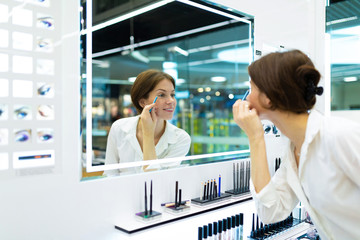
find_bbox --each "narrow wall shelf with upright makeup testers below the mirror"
[115,159,251,233]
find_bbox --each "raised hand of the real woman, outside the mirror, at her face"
[233,100,264,140]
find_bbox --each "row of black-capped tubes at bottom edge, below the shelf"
[198,213,244,240]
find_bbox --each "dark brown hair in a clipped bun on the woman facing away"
[248,50,323,113]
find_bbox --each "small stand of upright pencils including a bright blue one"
[191,175,231,205]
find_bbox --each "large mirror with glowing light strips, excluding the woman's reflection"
[81,0,253,177]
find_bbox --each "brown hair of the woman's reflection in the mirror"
[130,69,175,113]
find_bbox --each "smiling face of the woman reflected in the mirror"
[146,79,176,120]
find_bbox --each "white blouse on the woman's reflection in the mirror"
[104,116,191,176]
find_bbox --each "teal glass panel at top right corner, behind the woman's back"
[326,0,360,110]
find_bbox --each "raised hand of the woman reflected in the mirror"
[140,103,158,138]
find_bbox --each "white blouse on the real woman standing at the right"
[251,110,360,240]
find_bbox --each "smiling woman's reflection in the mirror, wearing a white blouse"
[104,69,191,175]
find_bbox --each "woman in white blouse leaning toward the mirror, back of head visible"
[233,50,360,239]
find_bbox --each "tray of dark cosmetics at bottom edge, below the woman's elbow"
[249,214,300,239]
